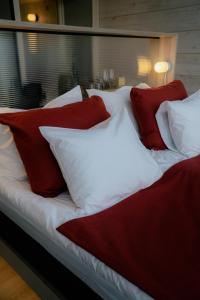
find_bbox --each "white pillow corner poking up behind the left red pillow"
[44,85,83,108]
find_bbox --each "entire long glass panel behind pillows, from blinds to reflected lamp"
[0,31,156,108]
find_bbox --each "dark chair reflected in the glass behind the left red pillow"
[21,82,45,109]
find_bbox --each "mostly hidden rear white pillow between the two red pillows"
[87,83,149,134]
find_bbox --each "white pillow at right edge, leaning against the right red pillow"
[156,90,200,157]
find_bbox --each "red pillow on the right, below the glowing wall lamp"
[131,80,187,150]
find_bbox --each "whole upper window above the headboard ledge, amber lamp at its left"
[20,0,92,27]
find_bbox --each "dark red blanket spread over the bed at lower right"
[58,156,200,300]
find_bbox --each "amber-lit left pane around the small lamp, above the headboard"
[20,0,59,24]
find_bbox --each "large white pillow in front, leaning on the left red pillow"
[40,109,162,209]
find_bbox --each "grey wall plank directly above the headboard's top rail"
[100,2,200,32]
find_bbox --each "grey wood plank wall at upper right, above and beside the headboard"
[99,0,200,93]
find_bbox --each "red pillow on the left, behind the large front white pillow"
[0,96,110,197]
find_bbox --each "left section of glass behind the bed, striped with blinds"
[0,31,92,108]
